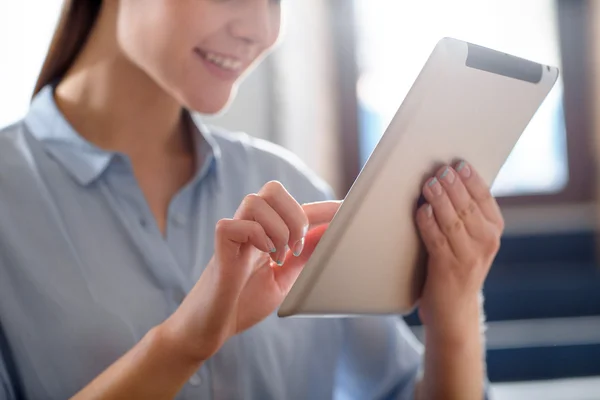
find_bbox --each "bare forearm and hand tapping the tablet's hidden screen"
[68,188,339,400]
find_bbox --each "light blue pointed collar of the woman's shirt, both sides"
[24,85,221,185]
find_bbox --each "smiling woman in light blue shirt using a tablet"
[0,0,502,399]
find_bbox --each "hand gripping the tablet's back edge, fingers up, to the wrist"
[417,161,504,339]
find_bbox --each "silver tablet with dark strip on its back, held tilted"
[278,38,558,317]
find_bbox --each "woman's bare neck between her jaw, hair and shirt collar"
[55,1,191,159]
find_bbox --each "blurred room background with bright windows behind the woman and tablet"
[0,0,600,400]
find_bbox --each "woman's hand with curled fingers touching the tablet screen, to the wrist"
[161,181,341,361]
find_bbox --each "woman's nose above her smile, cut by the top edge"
[231,0,280,47]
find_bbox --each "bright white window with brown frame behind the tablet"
[354,0,569,196]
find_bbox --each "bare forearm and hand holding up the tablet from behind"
[417,162,504,400]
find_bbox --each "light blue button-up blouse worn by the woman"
[0,86,421,400]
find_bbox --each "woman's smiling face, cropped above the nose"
[117,0,281,114]
